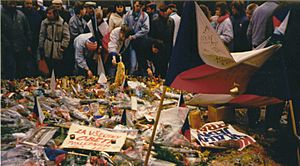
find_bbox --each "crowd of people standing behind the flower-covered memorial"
[1,0,296,79]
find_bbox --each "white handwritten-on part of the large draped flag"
[196,5,281,69]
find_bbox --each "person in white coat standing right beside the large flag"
[167,3,181,46]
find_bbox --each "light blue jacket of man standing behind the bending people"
[123,11,150,38]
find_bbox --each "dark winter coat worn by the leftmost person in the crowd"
[1,7,32,53]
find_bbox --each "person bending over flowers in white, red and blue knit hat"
[74,33,102,78]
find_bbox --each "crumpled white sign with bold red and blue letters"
[192,121,255,150]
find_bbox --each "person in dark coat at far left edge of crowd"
[1,1,32,79]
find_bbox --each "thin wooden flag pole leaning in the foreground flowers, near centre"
[144,86,167,166]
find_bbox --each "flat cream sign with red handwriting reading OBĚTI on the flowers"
[61,124,127,152]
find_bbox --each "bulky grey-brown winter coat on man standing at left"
[39,17,70,59]
